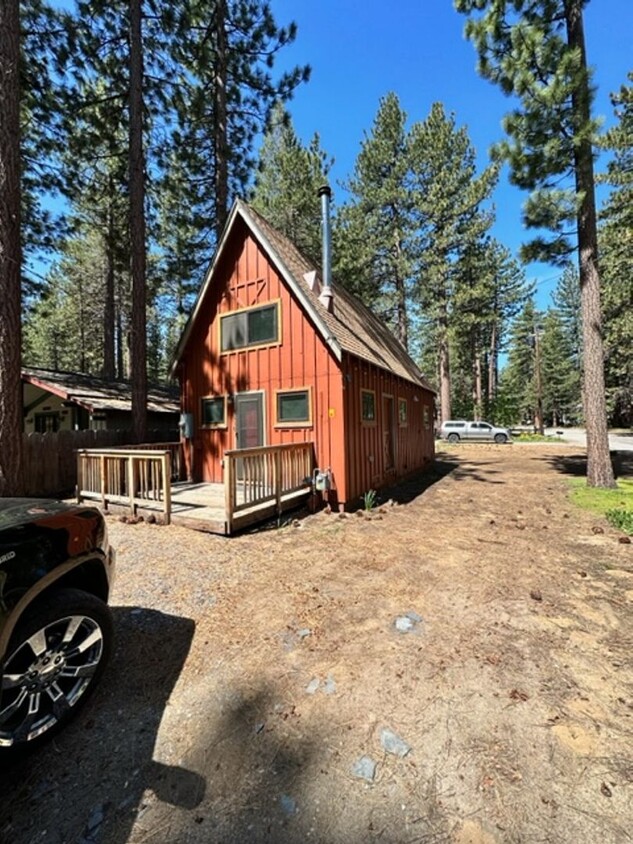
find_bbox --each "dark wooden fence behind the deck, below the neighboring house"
[22,430,181,497]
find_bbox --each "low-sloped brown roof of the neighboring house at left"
[22,367,179,413]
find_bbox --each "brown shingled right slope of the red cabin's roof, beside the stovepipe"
[240,202,433,391]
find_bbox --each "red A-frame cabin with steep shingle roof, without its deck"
[173,195,434,508]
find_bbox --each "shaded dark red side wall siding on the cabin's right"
[343,355,435,508]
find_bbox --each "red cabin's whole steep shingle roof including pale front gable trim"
[174,199,433,391]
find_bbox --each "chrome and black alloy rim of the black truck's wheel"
[0,615,103,747]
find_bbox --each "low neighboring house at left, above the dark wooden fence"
[22,368,179,435]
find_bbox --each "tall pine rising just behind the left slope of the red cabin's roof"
[164,0,310,258]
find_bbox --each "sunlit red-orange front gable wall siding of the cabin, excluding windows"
[181,222,347,501]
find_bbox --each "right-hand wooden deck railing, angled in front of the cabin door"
[224,442,314,533]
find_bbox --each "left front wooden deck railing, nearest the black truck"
[77,445,172,524]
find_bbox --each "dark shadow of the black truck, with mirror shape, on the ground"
[0,607,205,844]
